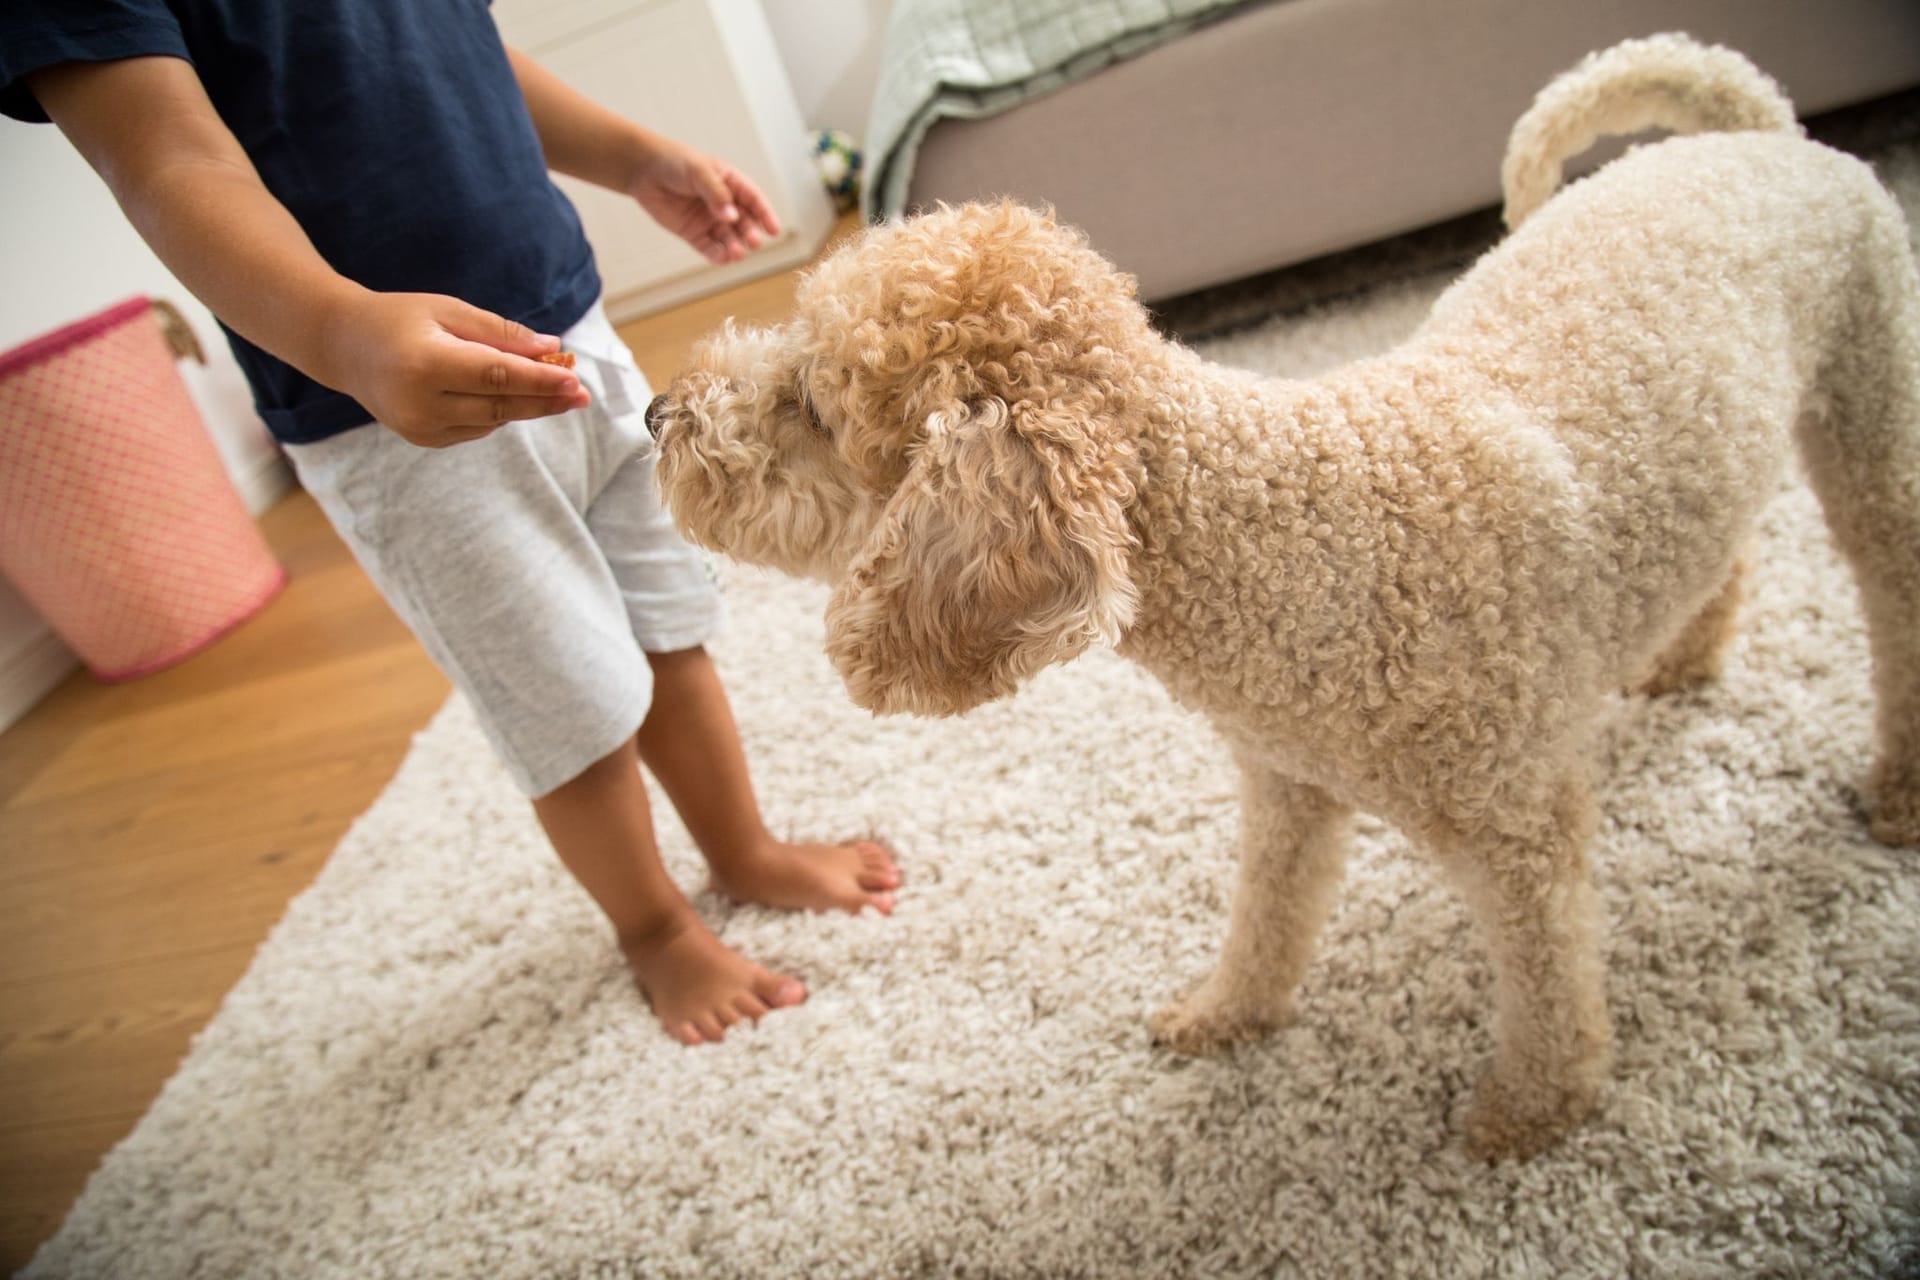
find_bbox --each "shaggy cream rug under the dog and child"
[31,160,1920,1278]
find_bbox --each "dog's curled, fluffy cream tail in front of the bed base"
[1500,35,1801,230]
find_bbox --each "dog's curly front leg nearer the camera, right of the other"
[1423,766,1613,1159]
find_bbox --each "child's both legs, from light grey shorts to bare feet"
[288,313,899,1042]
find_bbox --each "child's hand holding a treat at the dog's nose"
[317,290,589,449]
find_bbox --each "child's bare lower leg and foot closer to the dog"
[639,649,900,912]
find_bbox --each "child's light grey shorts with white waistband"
[286,307,724,796]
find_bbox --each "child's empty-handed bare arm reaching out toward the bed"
[507,48,780,263]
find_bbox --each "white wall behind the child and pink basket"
[0,0,891,729]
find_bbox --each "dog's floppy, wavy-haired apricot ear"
[828,395,1135,716]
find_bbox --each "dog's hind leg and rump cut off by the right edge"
[1799,211,1920,844]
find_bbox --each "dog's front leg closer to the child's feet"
[1152,758,1352,1054]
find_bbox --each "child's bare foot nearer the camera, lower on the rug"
[620,912,806,1044]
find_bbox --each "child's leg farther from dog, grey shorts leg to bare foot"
[288,378,871,1042]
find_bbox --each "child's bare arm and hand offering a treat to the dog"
[29,58,586,447]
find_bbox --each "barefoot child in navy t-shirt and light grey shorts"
[0,0,900,1044]
